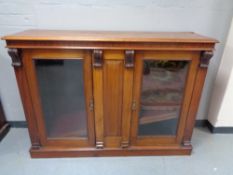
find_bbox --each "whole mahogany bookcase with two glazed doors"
[3,30,217,158]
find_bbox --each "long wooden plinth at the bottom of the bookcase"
[30,146,191,158]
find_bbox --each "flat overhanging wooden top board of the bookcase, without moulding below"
[2,30,218,43]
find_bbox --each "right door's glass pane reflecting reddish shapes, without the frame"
[138,60,188,136]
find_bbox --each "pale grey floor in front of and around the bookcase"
[0,128,233,175]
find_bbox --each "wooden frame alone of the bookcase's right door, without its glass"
[131,51,200,147]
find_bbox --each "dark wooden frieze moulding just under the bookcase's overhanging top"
[7,40,214,51]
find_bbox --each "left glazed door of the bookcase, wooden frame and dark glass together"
[23,49,95,147]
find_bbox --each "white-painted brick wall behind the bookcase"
[0,0,233,121]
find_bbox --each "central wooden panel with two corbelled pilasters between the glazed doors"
[93,50,134,148]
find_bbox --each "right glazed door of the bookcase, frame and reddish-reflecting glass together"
[131,51,199,146]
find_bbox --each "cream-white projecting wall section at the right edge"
[208,19,233,127]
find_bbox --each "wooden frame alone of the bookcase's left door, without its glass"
[22,49,95,147]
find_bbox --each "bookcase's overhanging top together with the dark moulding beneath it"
[2,30,218,51]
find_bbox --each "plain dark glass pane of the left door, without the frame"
[35,60,87,138]
